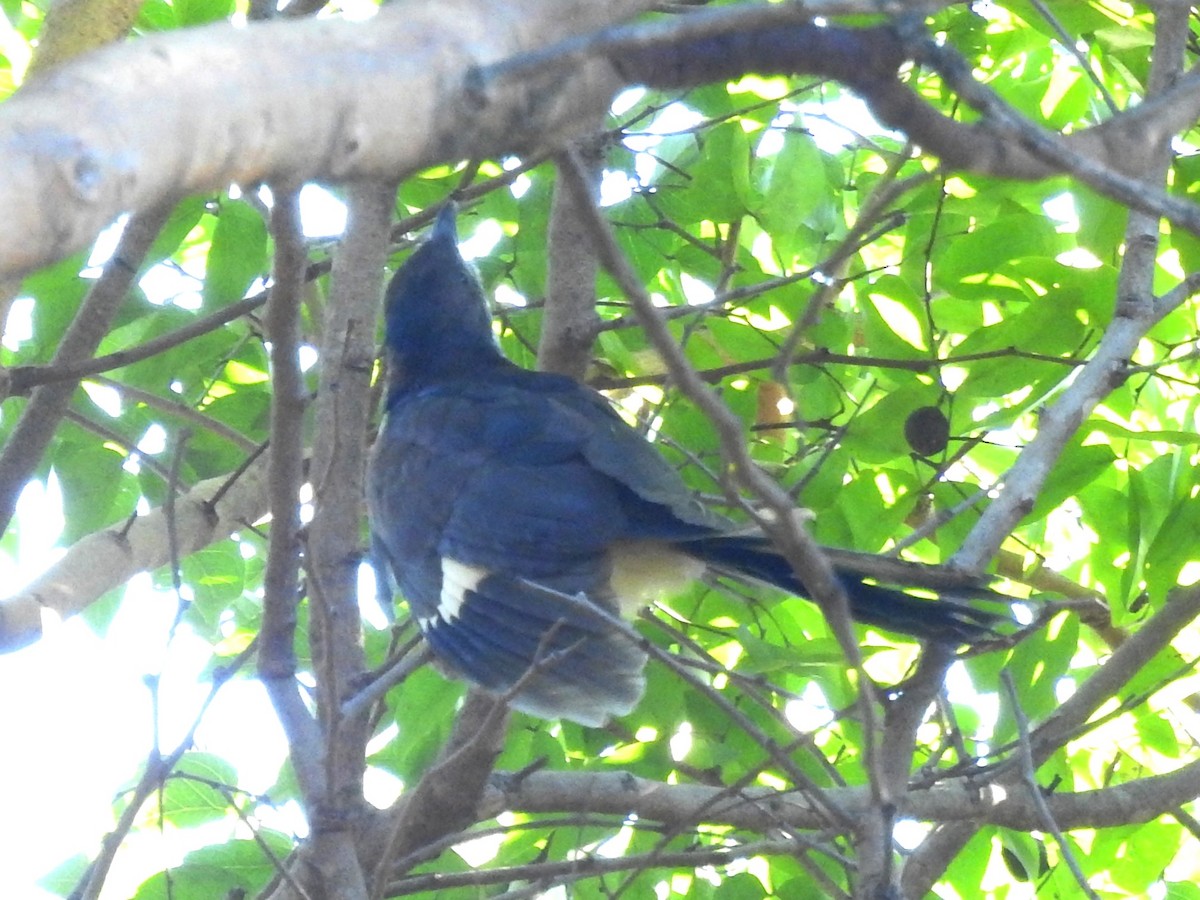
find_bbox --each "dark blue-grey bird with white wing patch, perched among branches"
[367,203,1000,727]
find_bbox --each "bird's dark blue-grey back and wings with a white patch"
[370,372,706,724]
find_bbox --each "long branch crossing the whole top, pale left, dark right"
[7,0,1200,275]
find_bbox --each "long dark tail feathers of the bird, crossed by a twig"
[679,535,1013,644]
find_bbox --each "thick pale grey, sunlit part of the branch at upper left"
[0,0,653,274]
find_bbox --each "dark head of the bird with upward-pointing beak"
[385,203,504,394]
